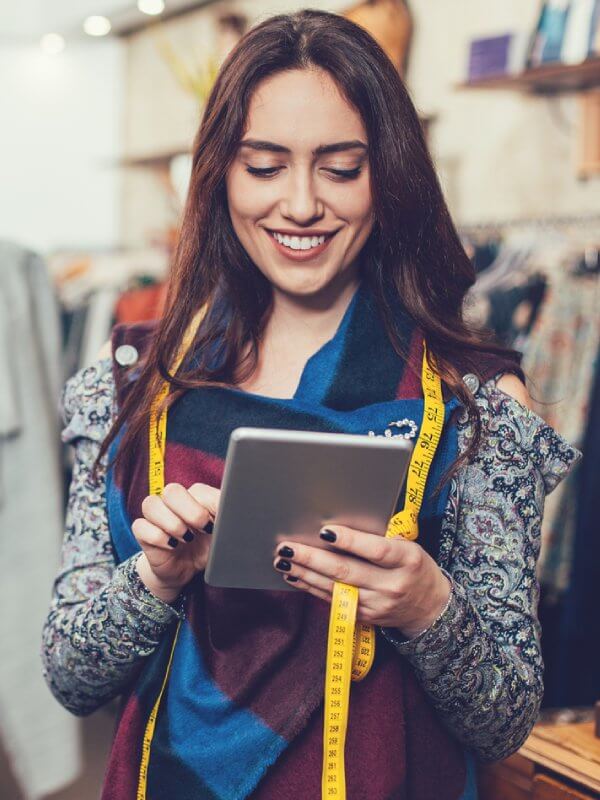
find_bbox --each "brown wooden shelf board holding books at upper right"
[457,56,600,94]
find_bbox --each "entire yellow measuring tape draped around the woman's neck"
[136,306,444,800]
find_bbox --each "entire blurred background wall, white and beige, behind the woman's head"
[0,0,600,251]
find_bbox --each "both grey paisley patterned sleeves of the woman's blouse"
[38,359,579,760]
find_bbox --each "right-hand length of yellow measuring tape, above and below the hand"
[321,347,444,800]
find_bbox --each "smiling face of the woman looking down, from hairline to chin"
[226,69,374,296]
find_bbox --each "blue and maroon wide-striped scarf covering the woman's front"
[103,281,488,800]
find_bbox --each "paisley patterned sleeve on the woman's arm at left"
[42,358,182,715]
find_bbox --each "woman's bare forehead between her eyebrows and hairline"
[245,69,367,150]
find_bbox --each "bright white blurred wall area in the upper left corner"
[0,5,126,252]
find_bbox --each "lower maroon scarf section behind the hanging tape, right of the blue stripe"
[252,638,466,800]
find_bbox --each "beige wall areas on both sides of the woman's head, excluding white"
[123,0,600,244]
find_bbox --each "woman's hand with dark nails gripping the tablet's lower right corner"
[273,525,451,638]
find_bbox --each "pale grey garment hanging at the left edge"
[0,241,80,798]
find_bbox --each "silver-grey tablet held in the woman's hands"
[204,427,413,591]
